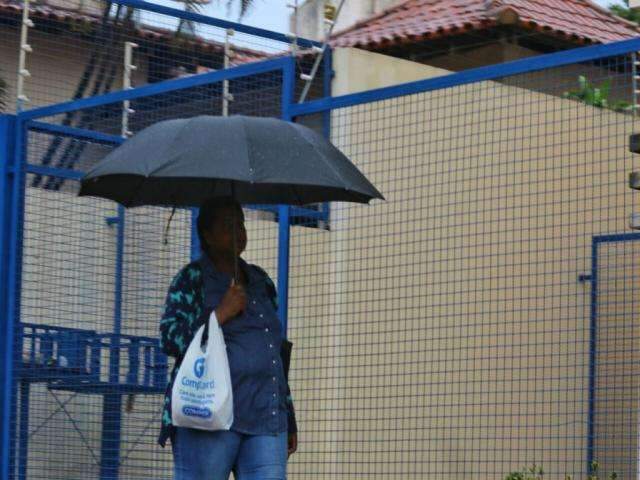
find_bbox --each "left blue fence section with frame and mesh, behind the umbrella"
[0,53,319,479]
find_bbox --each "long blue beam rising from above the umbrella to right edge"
[289,38,640,116]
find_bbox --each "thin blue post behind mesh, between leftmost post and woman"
[100,205,125,480]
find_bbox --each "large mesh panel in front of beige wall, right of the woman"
[289,54,639,479]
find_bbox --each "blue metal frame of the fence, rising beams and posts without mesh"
[0,27,640,480]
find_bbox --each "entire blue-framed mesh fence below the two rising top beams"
[0,5,640,480]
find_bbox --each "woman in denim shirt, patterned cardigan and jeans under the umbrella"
[159,199,297,480]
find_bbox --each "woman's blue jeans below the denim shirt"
[172,427,287,480]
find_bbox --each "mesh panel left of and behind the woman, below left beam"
[9,55,282,479]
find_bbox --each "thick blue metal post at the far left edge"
[0,115,16,480]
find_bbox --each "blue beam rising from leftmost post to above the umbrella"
[18,57,289,121]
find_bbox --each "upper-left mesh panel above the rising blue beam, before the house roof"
[0,0,324,111]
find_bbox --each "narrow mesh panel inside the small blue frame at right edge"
[591,235,640,478]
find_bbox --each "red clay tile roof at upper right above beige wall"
[332,0,640,48]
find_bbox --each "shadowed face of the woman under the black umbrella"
[204,205,247,256]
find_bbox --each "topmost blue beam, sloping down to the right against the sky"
[114,0,322,47]
